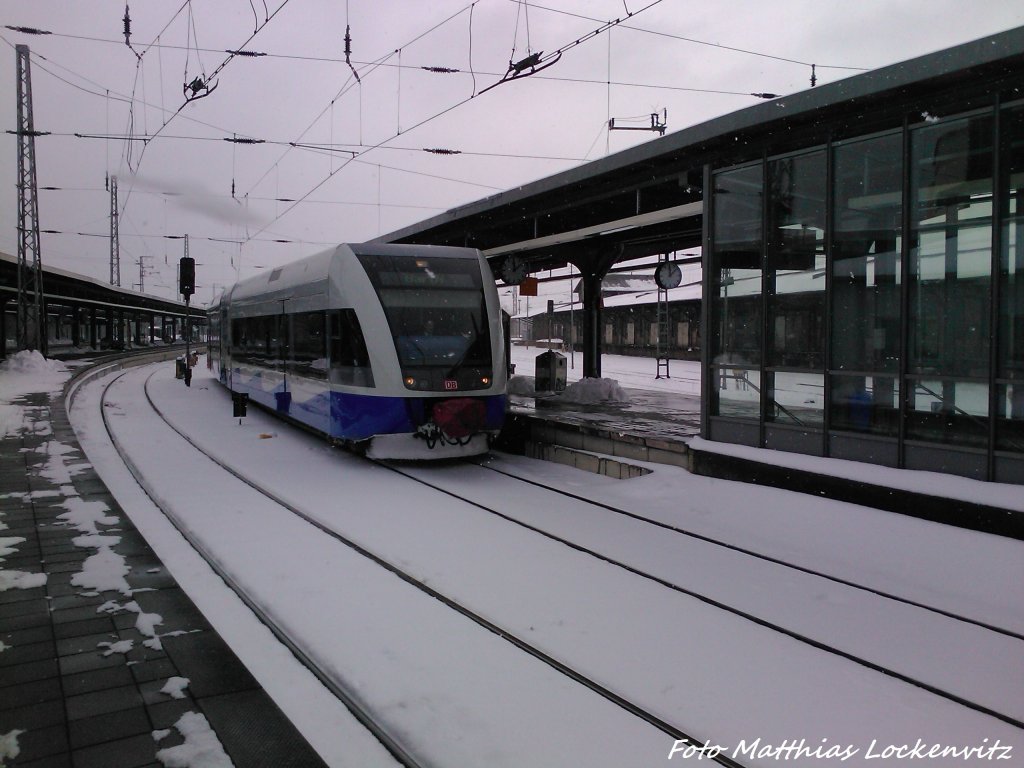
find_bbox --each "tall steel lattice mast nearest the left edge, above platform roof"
[14,45,46,354]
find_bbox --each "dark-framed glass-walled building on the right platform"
[703,99,1024,483]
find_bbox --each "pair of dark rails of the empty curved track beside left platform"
[94,364,743,768]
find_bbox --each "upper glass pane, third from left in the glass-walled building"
[831,133,903,374]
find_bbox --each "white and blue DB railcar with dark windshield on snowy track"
[208,243,508,459]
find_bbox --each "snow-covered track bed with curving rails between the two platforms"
[74,367,1024,768]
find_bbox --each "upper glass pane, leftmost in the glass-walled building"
[711,165,764,366]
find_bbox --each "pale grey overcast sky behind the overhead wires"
[0,0,1024,303]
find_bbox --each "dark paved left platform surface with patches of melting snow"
[0,368,324,768]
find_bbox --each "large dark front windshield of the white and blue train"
[358,255,490,388]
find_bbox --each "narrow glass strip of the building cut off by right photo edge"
[995,106,1024,452]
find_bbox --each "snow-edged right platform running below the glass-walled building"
[502,376,1024,539]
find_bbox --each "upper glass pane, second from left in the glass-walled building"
[767,152,825,369]
